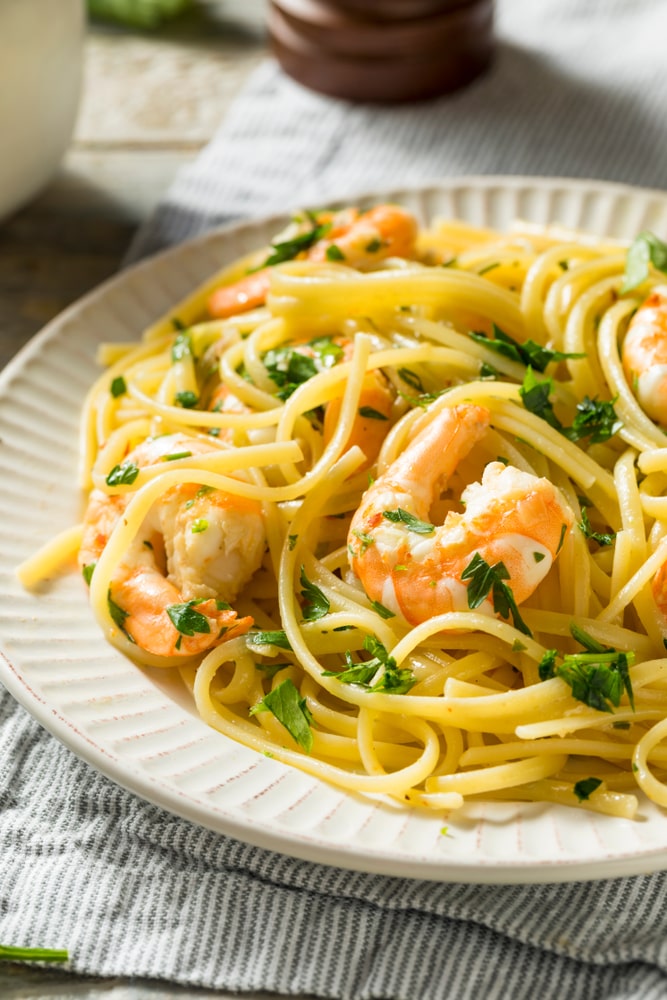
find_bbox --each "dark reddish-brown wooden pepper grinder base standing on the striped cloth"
[268,0,493,103]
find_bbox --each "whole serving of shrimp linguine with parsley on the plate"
[19,206,667,817]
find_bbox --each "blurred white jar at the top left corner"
[0,0,85,219]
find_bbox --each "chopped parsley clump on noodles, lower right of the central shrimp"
[539,623,635,712]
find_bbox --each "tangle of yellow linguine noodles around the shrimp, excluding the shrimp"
[22,211,667,817]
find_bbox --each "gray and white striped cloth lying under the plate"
[0,0,667,1000]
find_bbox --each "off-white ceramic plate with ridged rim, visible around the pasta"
[0,177,667,882]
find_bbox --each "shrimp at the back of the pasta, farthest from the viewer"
[208,205,417,318]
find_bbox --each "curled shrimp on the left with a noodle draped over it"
[79,434,265,656]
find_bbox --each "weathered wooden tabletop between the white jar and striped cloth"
[0,0,267,367]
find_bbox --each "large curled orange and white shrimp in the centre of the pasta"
[348,404,574,625]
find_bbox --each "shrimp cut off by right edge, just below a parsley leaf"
[622,288,667,425]
